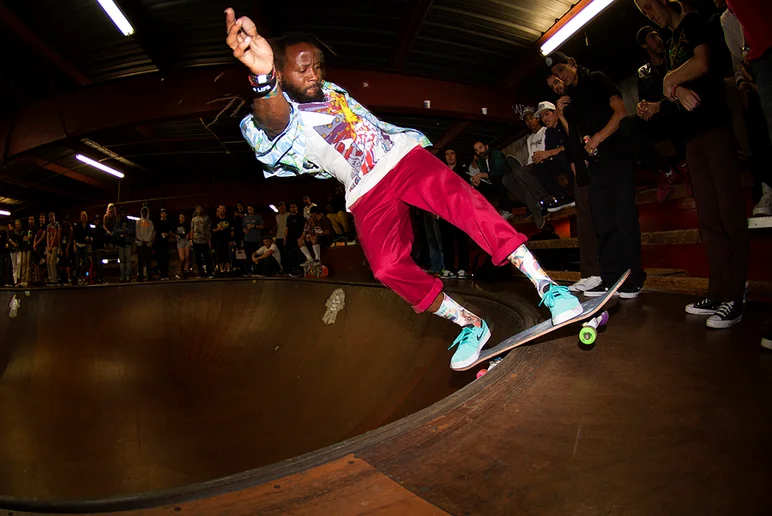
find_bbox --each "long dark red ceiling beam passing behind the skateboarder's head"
[0,66,516,157]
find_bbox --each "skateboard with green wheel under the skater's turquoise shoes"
[457,270,630,371]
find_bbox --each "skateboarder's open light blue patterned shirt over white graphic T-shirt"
[241,82,431,192]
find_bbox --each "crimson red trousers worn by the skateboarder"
[351,147,527,312]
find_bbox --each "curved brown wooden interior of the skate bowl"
[0,279,536,512]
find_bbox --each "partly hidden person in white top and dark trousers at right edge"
[716,0,772,217]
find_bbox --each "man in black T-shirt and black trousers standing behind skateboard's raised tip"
[546,52,646,299]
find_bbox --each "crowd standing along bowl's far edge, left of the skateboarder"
[0,196,356,288]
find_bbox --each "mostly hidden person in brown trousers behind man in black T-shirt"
[547,73,603,292]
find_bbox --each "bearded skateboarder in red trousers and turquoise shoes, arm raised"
[225,8,582,367]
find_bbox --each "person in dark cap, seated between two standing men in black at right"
[619,25,684,202]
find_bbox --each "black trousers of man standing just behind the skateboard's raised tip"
[589,156,646,286]
